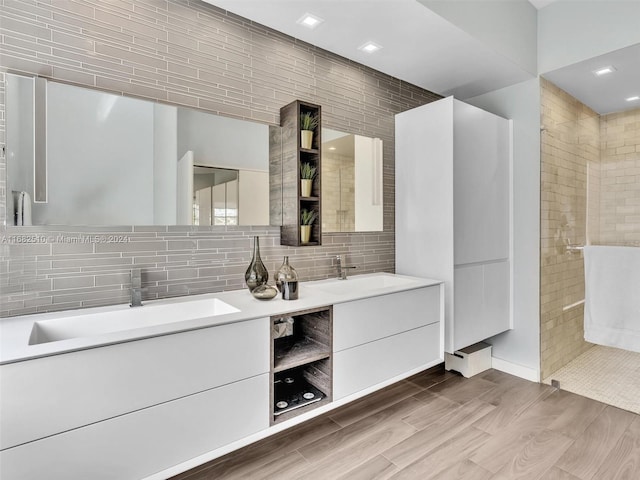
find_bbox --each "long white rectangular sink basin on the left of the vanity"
[29,298,240,345]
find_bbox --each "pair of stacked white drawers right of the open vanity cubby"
[333,285,442,400]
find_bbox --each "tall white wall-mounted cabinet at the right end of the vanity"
[396,97,512,353]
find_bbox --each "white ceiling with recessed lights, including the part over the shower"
[204,0,640,114]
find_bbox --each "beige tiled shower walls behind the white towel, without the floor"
[540,80,640,379]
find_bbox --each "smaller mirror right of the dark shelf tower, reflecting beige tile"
[322,128,383,232]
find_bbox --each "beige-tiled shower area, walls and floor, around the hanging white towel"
[540,79,640,413]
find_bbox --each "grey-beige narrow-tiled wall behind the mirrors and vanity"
[0,0,439,316]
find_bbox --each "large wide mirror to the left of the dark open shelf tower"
[6,74,274,226]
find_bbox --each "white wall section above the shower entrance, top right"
[538,0,640,73]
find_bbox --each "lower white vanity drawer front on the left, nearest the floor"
[0,376,269,480]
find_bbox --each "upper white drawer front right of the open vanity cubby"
[333,280,441,352]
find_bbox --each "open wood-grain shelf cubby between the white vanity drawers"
[270,306,333,424]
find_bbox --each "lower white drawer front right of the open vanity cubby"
[333,323,442,400]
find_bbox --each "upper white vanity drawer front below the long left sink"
[0,318,269,450]
